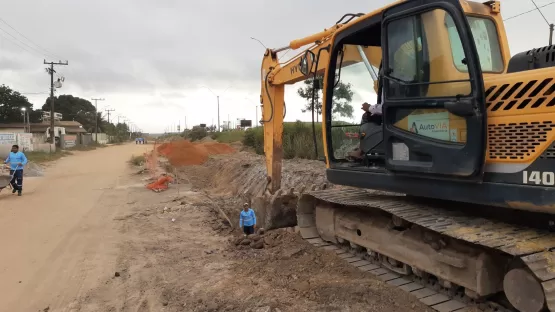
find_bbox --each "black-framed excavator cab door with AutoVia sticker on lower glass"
[381,0,486,180]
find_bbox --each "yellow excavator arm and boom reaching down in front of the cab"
[260,21,382,194]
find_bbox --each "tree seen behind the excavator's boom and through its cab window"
[297,76,354,118]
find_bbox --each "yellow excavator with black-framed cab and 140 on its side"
[261,0,555,312]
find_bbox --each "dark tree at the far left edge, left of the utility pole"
[0,85,42,123]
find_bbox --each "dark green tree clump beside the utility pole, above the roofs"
[42,95,106,133]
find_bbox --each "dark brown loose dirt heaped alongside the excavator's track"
[224,229,431,312]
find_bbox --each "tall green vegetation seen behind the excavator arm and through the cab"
[243,121,358,159]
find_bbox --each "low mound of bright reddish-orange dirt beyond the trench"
[156,140,235,166]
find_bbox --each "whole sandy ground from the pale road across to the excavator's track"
[0,145,431,312]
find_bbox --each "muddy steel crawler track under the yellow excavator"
[297,189,555,312]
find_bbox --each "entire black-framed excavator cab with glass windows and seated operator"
[308,0,496,182]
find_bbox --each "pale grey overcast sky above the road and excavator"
[0,0,555,132]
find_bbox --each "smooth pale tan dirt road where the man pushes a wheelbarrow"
[0,144,150,312]
